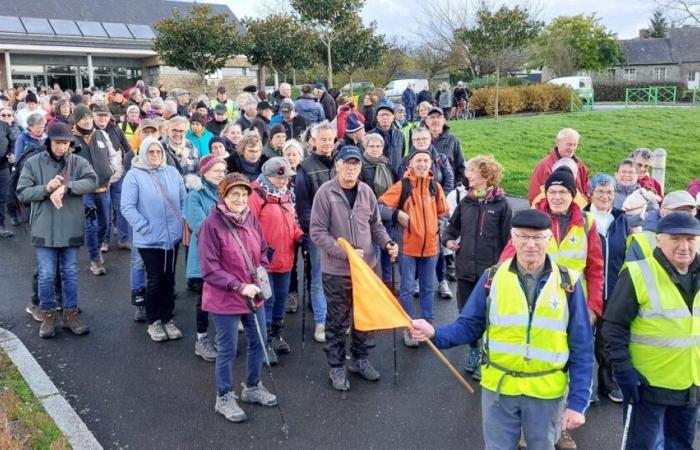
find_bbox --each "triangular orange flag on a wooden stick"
[338,238,411,331]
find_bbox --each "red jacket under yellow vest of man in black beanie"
[499,198,604,317]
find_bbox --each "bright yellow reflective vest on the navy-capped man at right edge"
[626,257,700,390]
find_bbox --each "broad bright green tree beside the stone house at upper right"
[532,14,625,76]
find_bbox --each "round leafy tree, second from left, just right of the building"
[243,14,318,81]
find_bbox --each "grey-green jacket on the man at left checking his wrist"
[17,141,97,248]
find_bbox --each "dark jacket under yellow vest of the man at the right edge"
[602,248,700,405]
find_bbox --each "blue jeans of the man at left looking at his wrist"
[36,247,78,310]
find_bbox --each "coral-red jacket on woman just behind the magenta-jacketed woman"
[248,181,304,273]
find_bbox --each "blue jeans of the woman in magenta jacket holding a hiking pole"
[210,308,267,396]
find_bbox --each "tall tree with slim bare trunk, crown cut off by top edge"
[290,0,365,87]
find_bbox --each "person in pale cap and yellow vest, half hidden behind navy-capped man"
[625,191,698,261]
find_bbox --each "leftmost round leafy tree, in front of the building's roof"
[153,3,242,86]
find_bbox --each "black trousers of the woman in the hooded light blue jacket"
[139,246,178,325]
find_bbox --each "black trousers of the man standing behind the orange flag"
[322,273,375,367]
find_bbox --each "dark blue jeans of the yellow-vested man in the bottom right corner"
[623,395,699,450]
